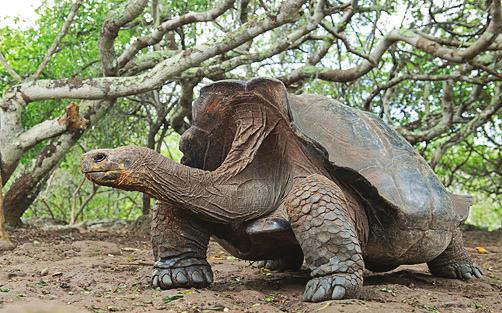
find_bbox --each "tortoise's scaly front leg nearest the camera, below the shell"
[286,175,367,302]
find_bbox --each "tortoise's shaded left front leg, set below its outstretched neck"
[152,202,213,289]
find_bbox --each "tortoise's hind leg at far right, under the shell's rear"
[427,229,483,279]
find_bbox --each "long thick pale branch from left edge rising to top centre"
[11,0,304,102]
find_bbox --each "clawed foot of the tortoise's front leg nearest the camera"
[303,273,363,302]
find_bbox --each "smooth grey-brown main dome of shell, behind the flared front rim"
[289,95,466,230]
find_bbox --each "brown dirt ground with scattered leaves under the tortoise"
[0,229,502,313]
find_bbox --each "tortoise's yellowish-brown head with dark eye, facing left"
[80,146,154,190]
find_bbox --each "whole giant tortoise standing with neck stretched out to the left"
[82,78,482,301]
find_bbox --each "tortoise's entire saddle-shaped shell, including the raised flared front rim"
[181,78,469,230]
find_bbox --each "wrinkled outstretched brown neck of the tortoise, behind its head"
[139,154,278,223]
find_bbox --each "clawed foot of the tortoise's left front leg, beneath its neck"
[152,261,213,289]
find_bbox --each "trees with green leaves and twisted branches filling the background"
[0,0,502,241]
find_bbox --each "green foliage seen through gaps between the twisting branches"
[0,0,502,229]
